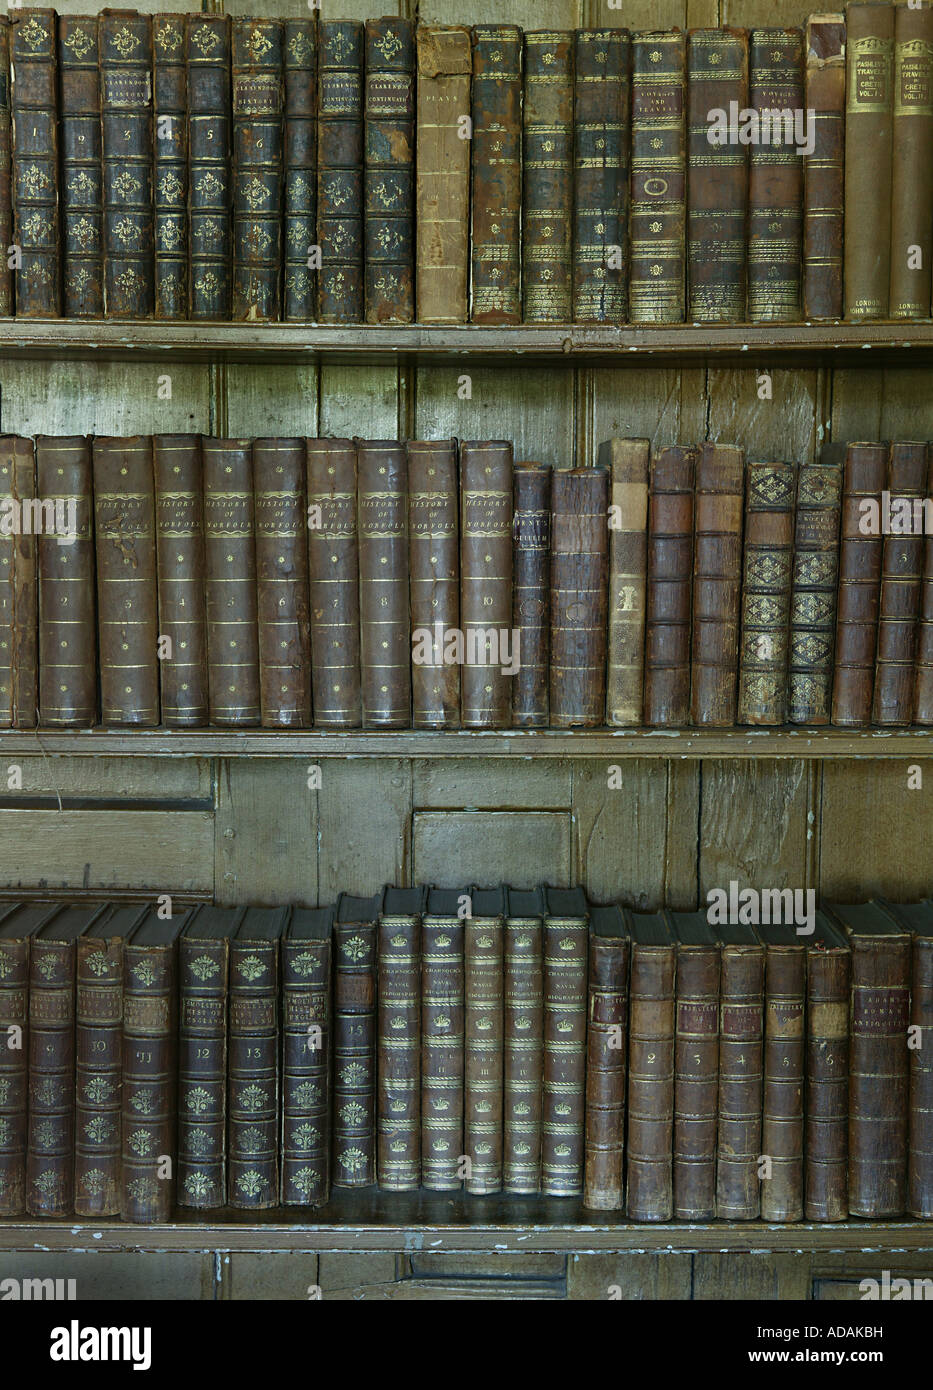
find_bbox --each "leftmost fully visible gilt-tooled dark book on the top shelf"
[11,10,61,318]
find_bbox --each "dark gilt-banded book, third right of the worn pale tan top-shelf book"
[573,29,631,324]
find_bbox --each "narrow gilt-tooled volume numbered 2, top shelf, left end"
[59,14,104,318]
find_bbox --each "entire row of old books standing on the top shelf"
[0,0,933,324]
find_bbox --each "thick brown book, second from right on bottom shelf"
[826,902,912,1220]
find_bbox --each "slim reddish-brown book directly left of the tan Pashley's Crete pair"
[804,14,845,320]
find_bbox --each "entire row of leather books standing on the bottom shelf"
[0,887,933,1222]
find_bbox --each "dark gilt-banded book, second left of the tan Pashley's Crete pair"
[748,29,804,324]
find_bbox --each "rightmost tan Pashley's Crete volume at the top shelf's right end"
[889,0,933,318]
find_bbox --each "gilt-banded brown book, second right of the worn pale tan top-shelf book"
[521,29,573,324]
